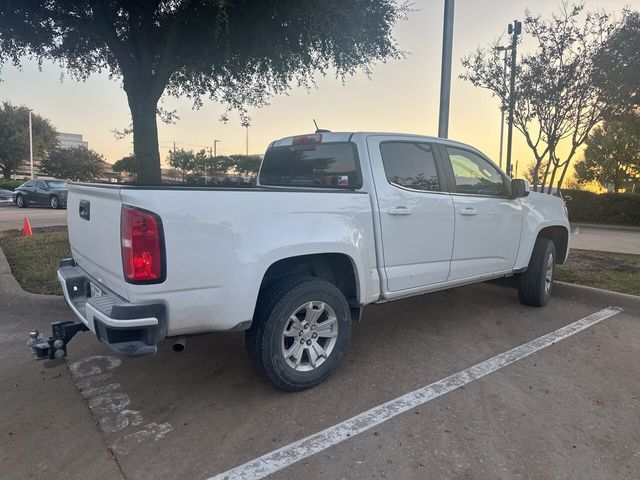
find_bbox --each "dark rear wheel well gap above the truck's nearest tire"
[260,253,360,307]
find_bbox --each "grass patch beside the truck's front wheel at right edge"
[556,250,640,295]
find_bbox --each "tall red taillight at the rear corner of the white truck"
[120,205,164,283]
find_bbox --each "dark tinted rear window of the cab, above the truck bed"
[259,142,362,190]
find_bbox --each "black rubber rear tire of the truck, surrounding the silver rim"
[245,277,351,392]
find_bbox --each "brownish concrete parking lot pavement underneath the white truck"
[0,258,640,479]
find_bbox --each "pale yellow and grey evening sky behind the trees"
[0,0,633,172]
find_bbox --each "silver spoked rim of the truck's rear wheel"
[281,301,338,372]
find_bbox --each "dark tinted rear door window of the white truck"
[380,142,441,192]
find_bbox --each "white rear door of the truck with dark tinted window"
[368,136,454,292]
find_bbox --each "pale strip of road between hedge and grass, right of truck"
[571,226,640,255]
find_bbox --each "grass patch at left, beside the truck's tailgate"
[0,232,71,295]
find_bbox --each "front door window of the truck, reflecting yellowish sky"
[447,147,508,196]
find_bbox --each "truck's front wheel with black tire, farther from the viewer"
[518,238,556,307]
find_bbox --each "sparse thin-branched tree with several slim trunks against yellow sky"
[461,4,613,193]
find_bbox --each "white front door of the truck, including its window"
[441,145,522,281]
